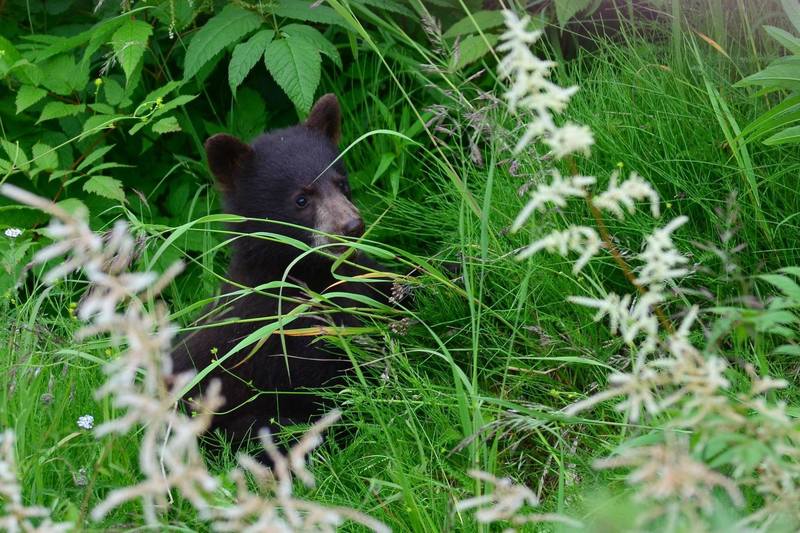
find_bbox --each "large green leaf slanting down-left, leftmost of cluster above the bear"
[183,4,261,80]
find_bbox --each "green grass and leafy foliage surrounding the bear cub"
[0,0,800,531]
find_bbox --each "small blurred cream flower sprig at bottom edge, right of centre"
[455,470,581,533]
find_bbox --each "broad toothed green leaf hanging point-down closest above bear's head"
[264,38,322,113]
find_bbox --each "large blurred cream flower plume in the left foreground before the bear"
[0,185,388,532]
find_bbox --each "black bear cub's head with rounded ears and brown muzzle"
[205,94,364,260]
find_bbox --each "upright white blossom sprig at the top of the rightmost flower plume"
[636,216,689,286]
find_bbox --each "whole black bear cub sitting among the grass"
[172,94,387,440]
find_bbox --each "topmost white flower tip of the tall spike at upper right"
[497,10,594,159]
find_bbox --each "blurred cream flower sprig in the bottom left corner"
[0,429,72,533]
